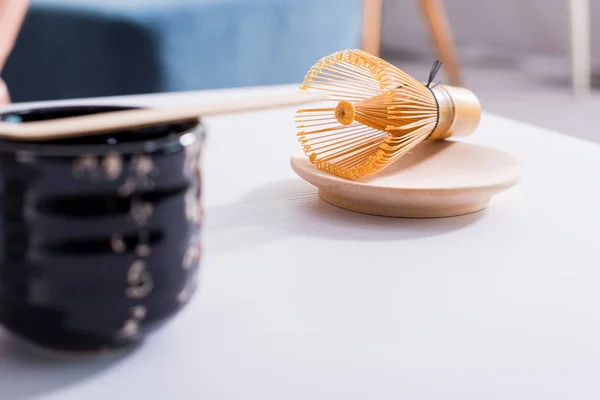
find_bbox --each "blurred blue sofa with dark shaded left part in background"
[3,0,363,101]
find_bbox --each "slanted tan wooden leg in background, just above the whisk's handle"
[419,0,462,86]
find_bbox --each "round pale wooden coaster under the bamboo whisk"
[291,141,523,218]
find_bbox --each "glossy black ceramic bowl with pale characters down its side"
[0,106,204,351]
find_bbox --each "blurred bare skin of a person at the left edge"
[0,0,28,104]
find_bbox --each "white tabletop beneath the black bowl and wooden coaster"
[0,87,600,400]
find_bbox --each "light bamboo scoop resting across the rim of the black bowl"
[0,91,326,141]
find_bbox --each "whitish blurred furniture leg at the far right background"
[569,0,591,94]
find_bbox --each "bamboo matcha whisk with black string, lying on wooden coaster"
[296,50,480,179]
